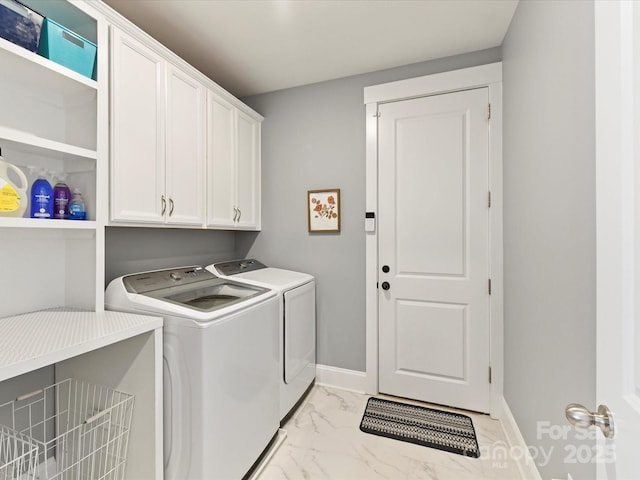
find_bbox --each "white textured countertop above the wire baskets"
[0,309,162,381]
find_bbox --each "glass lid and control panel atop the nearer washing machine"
[122,266,269,312]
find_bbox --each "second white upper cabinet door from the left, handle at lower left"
[165,64,206,225]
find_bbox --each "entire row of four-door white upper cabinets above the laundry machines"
[109,10,263,230]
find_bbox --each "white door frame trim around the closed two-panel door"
[364,62,504,418]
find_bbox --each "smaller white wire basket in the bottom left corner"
[0,425,38,480]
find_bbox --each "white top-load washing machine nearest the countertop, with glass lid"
[105,267,280,480]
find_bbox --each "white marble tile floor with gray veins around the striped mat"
[258,385,521,480]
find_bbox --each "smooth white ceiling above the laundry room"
[104,0,518,97]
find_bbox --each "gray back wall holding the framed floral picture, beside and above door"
[242,48,501,371]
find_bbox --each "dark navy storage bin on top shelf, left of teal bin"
[0,0,44,52]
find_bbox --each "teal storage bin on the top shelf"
[38,18,97,78]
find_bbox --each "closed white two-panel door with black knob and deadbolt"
[378,88,490,412]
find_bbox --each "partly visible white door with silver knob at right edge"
[592,0,640,480]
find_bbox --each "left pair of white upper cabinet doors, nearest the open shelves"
[110,27,206,226]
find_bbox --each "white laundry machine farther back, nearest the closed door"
[207,259,316,420]
